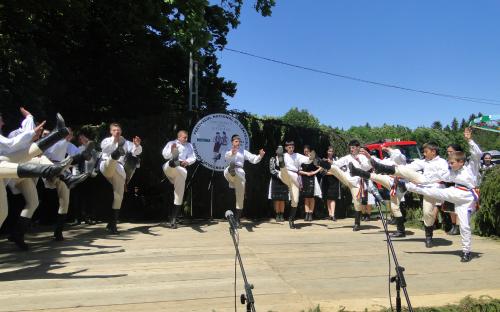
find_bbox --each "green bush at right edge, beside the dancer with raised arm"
[473,166,500,236]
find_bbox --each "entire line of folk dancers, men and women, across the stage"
[0,108,488,262]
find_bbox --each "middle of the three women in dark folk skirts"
[299,145,321,221]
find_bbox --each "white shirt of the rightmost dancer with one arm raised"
[443,140,483,189]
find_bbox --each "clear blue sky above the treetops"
[219,0,500,128]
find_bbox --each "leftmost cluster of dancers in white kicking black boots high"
[0,108,142,250]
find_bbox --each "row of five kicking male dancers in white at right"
[271,129,482,262]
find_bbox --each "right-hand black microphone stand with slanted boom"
[369,189,413,312]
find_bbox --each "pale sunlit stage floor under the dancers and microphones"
[0,219,500,312]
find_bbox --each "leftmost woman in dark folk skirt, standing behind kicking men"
[268,156,290,222]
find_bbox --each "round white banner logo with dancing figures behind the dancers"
[191,114,250,171]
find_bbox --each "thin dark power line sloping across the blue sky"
[225,48,500,106]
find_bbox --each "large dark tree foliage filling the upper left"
[0,0,275,128]
